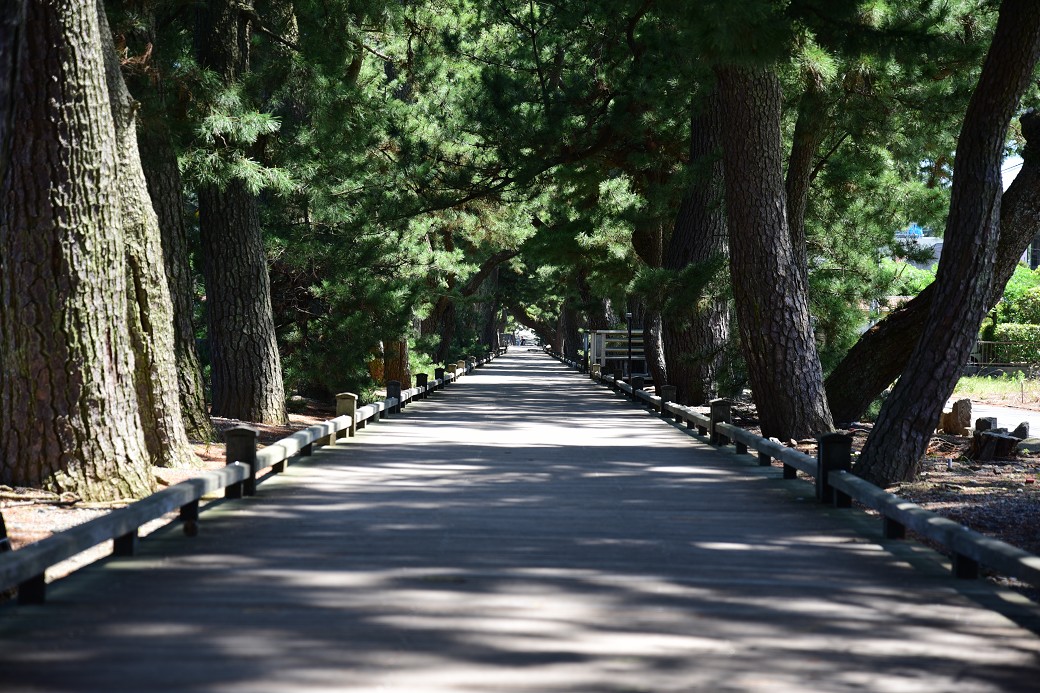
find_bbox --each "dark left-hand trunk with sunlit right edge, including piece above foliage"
[196,0,288,424]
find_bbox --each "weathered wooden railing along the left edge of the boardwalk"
[0,355,495,604]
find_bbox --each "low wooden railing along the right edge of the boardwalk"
[552,354,1040,587]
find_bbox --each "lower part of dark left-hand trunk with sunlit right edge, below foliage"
[198,181,287,424]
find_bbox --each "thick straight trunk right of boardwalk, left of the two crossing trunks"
[717,67,833,439]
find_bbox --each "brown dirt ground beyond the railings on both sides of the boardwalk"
[6,397,1040,599]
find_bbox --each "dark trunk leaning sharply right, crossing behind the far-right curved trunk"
[827,111,1040,421]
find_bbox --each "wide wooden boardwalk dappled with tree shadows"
[0,353,1040,693]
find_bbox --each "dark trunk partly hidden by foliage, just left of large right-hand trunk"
[664,91,729,404]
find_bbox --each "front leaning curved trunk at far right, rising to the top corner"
[856,0,1040,486]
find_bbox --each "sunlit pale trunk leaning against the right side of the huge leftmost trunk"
[100,12,197,467]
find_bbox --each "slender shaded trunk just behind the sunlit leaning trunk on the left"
[137,130,213,440]
